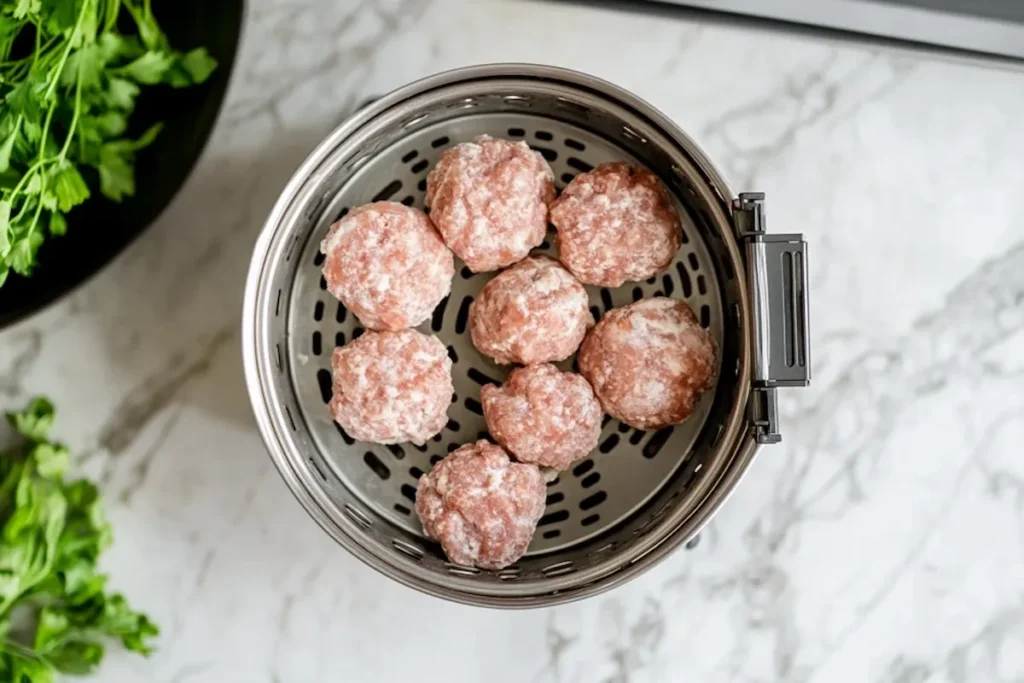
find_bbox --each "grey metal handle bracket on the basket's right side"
[733,193,811,443]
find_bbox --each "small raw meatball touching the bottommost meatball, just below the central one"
[480,364,604,470]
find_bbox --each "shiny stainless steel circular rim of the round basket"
[242,63,757,607]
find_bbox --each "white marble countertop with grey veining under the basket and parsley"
[0,0,1024,683]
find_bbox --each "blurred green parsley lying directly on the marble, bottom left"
[0,398,158,683]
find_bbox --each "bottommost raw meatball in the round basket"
[416,440,547,569]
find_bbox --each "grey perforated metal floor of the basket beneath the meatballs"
[287,113,723,559]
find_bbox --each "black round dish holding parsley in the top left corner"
[0,0,245,327]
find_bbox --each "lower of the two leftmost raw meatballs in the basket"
[329,330,454,444]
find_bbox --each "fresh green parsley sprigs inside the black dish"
[0,0,216,286]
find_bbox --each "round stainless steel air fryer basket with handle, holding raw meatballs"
[243,65,809,607]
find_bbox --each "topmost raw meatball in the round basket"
[427,135,555,272]
